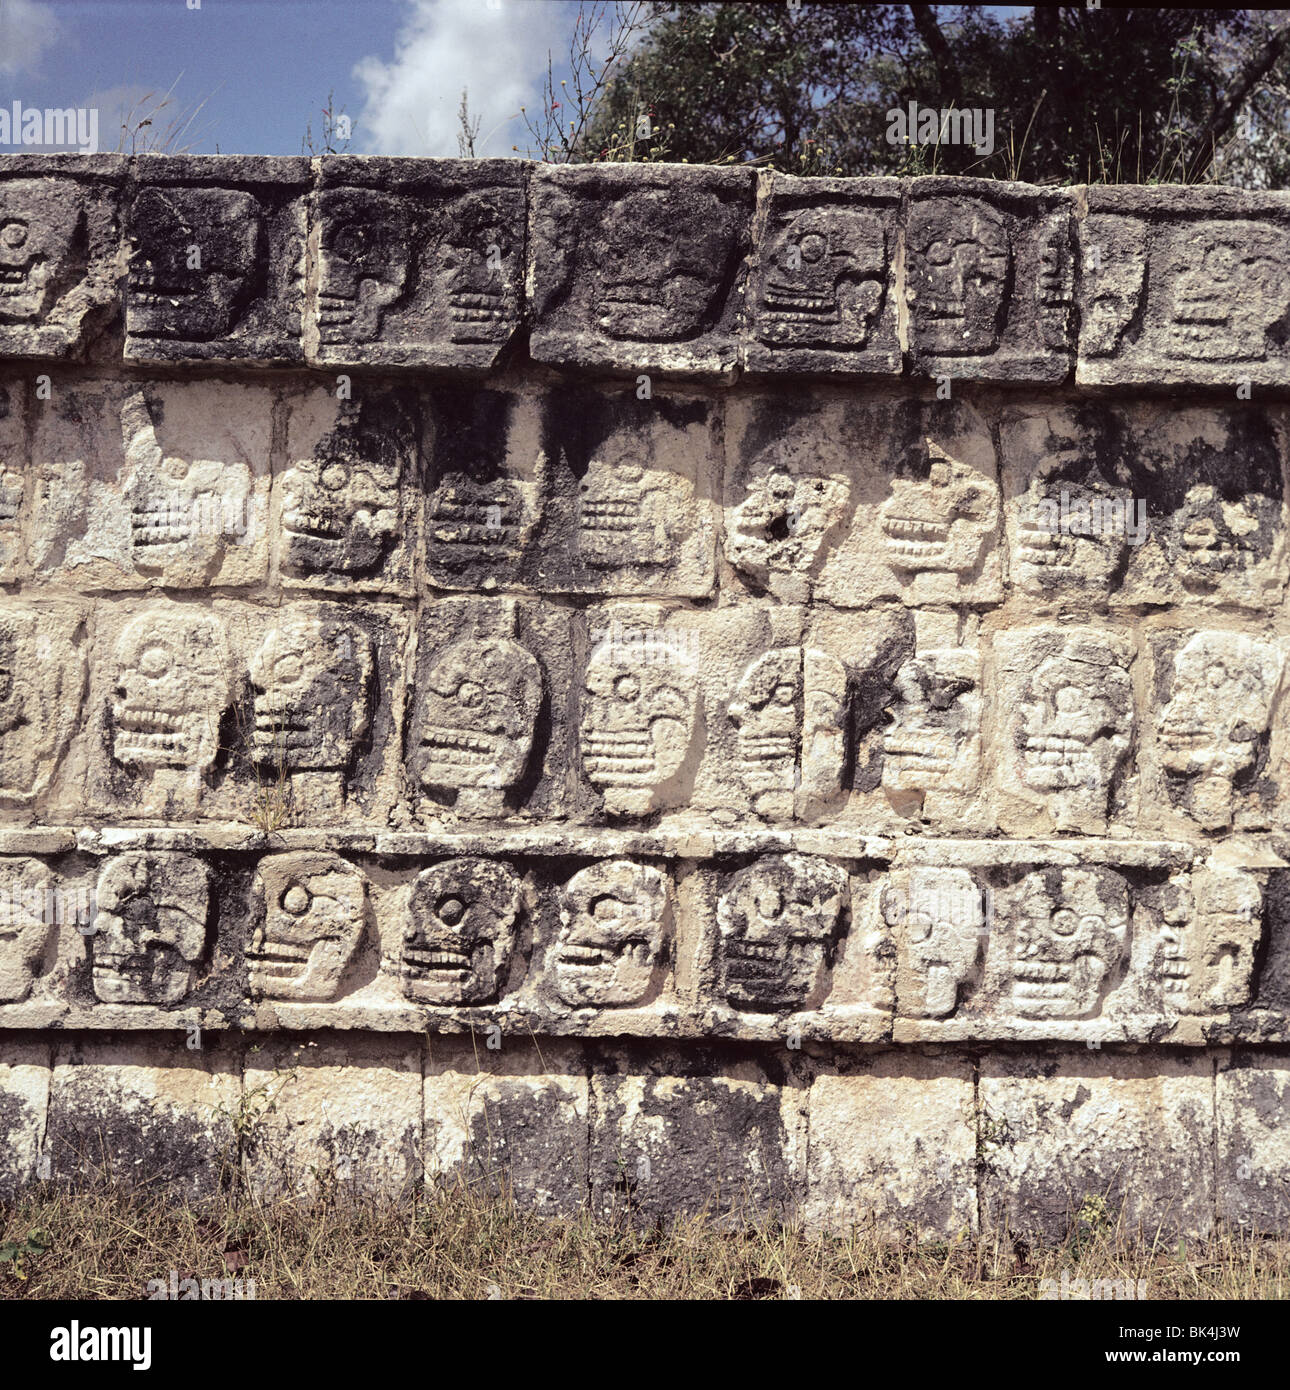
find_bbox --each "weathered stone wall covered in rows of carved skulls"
[0,156,1290,1237]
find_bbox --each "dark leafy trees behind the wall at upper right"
[573,0,1290,182]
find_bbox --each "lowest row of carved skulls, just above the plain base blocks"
[0,851,1262,1019]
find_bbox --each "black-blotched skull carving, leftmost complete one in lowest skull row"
[93,851,210,1004]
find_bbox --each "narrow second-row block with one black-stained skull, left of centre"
[270,382,421,594]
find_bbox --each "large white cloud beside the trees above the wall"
[354,0,578,156]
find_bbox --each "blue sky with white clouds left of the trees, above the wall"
[0,0,1034,156]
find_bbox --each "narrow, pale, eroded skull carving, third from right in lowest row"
[881,869,986,1019]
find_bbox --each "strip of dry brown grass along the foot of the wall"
[0,1184,1290,1300]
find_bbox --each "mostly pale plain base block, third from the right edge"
[803,1052,977,1240]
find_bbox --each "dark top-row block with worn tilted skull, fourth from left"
[530,164,753,377]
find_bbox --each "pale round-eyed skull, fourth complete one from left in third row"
[581,638,699,815]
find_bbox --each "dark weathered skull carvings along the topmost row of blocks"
[0,179,1290,361]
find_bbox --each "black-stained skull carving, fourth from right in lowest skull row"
[717,855,847,1009]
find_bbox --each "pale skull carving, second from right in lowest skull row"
[1012,869,1129,1019]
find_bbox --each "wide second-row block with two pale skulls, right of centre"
[724,396,1002,607]
